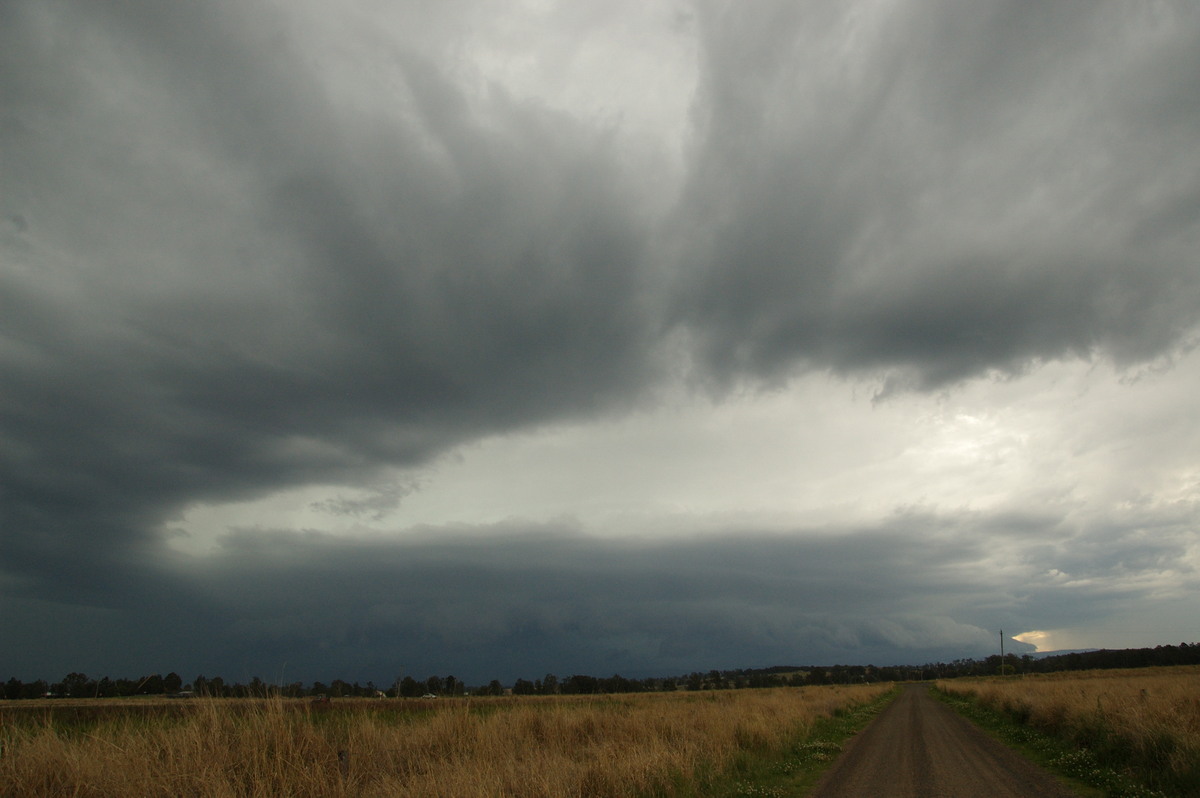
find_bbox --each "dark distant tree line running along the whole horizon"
[7,643,1200,701]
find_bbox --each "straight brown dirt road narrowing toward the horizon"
[811,685,1075,798]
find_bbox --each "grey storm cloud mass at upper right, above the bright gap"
[678,2,1200,385]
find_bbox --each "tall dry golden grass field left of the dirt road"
[0,685,890,798]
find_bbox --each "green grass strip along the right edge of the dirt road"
[930,689,1176,798]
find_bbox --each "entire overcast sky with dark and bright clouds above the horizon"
[7,0,1200,683]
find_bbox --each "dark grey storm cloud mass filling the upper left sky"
[0,4,650,578]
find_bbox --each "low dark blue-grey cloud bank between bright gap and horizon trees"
[6,514,1182,680]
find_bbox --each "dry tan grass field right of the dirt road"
[937,666,1200,794]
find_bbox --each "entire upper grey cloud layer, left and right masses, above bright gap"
[0,0,1200,657]
